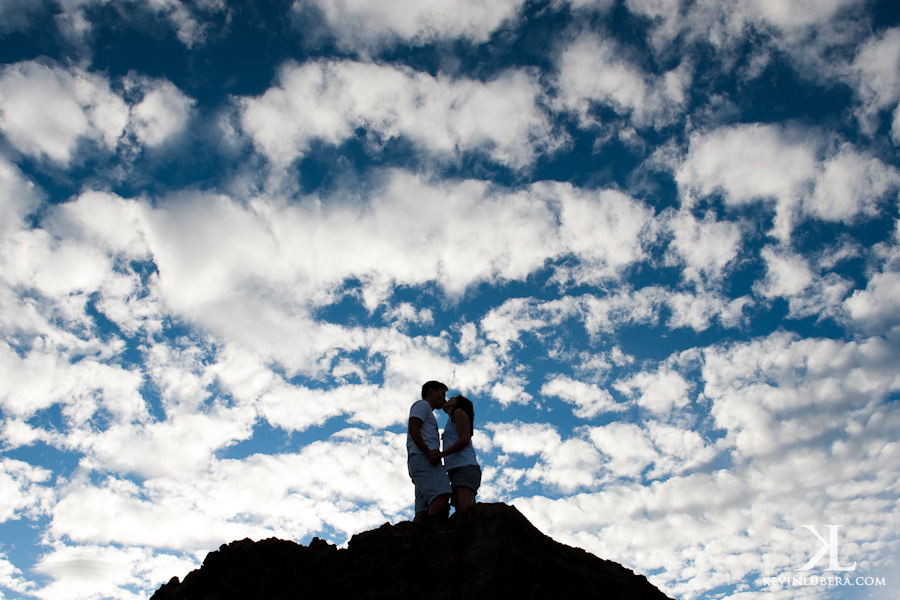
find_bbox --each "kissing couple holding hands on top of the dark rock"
[406,381,481,523]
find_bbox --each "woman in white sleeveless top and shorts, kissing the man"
[441,396,481,510]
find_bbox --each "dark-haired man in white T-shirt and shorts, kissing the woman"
[406,381,453,523]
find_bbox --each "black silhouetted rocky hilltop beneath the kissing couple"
[151,503,667,600]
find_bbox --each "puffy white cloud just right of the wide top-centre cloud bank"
[557,34,691,127]
